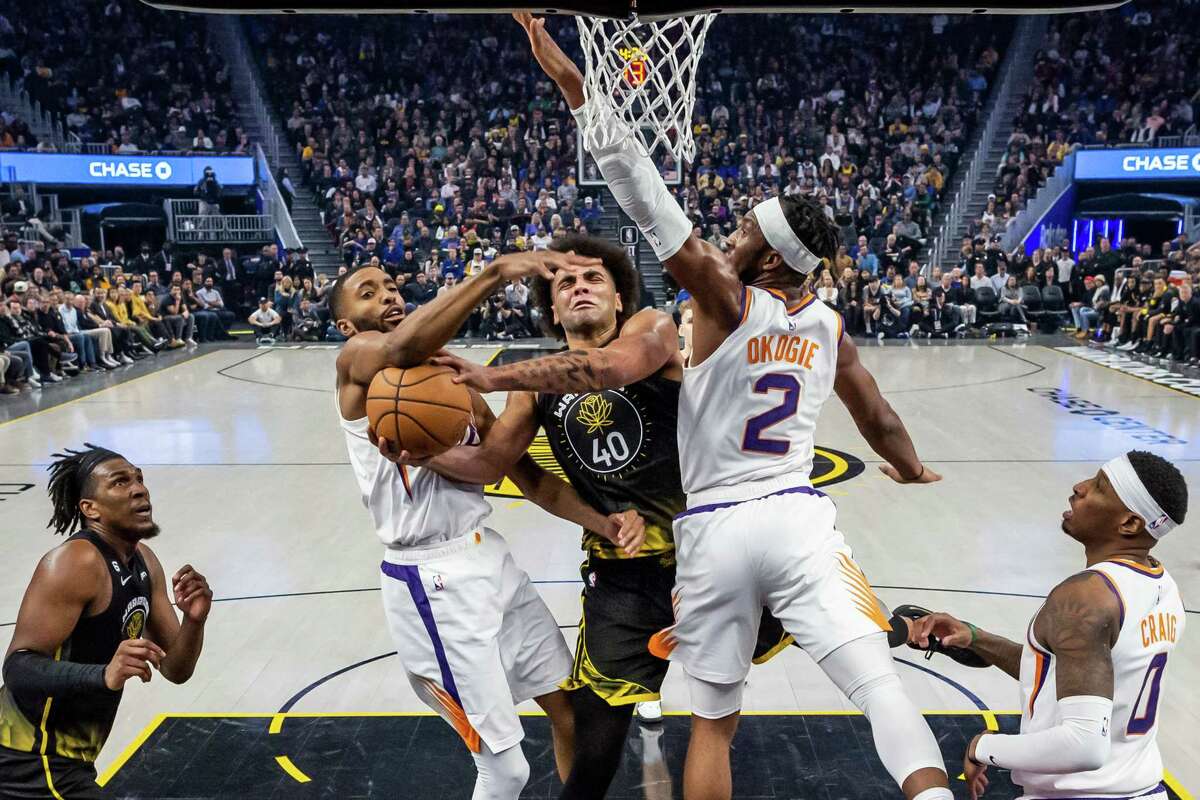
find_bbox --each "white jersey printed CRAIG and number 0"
[1013,560,1184,798]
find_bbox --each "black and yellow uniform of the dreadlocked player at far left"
[0,530,150,762]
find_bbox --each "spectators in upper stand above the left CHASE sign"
[0,0,243,154]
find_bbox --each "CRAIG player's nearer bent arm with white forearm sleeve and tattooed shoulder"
[966,572,1121,775]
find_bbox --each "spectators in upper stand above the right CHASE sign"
[968,0,1200,242]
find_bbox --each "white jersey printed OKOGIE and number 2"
[679,287,842,501]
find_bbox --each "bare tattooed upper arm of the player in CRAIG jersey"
[1034,573,1121,699]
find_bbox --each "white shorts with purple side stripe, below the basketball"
[382,528,571,753]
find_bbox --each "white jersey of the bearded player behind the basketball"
[337,398,492,547]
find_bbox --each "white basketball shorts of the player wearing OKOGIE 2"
[650,486,890,684]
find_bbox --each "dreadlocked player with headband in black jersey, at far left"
[0,445,212,800]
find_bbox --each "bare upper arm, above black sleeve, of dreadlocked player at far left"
[8,546,99,656]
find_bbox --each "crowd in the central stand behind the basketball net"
[250,14,1012,309]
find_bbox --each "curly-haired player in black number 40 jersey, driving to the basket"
[431,236,790,799]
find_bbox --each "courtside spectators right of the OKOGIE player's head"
[787,224,1200,367]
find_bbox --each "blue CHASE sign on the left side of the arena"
[0,152,254,188]
